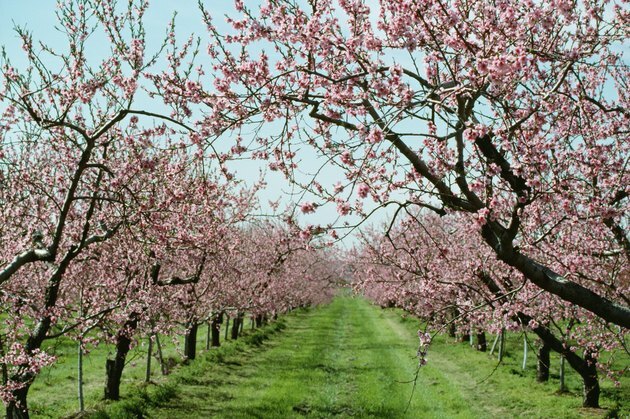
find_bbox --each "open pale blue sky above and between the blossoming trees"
[0,0,402,247]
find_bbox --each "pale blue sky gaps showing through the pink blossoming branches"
[0,0,404,245]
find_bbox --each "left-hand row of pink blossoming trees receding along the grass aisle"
[0,2,336,418]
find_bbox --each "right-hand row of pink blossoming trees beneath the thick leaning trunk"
[355,214,627,407]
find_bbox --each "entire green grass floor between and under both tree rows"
[22,296,630,419]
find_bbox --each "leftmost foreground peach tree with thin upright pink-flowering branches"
[0,1,207,418]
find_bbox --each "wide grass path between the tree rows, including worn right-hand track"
[148,296,628,419]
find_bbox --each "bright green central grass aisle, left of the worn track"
[150,297,496,418]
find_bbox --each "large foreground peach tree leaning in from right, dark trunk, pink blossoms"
[155,0,630,328]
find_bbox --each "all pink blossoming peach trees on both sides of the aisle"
[0,0,630,417]
